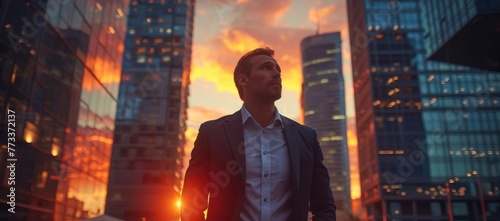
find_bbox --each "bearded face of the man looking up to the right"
[243,55,281,102]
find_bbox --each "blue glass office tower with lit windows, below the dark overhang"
[347,0,500,220]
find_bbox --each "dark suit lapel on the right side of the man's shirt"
[281,115,300,194]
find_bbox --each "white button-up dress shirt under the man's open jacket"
[240,106,292,221]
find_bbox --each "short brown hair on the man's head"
[233,47,274,100]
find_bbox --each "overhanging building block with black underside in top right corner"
[421,0,500,72]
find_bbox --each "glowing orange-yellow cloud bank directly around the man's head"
[191,27,312,94]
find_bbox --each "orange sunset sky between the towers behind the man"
[186,0,360,198]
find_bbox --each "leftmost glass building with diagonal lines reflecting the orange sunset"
[0,0,127,221]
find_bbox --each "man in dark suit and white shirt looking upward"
[181,48,336,221]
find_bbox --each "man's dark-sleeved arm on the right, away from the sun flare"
[309,130,336,221]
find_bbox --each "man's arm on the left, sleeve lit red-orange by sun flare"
[180,124,210,221]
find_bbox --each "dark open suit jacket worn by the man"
[181,111,336,221]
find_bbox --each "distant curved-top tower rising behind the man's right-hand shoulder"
[301,32,351,218]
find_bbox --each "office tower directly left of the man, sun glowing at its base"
[106,0,194,220]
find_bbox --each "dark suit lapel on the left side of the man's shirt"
[224,111,246,180]
